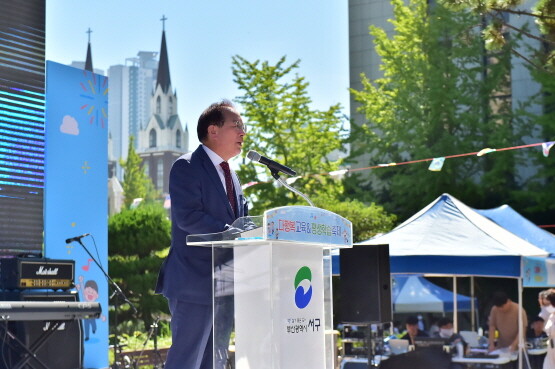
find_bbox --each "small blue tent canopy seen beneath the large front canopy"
[391,275,472,313]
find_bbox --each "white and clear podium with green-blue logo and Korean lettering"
[187,206,353,369]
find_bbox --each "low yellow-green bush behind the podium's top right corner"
[314,198,397,242]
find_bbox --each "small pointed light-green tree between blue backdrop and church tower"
[121,136,159,208]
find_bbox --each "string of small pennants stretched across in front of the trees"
[242,141,555,190]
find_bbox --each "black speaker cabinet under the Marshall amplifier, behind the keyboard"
[0,291,83,369]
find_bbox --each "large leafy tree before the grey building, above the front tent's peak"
[346,0,527,219]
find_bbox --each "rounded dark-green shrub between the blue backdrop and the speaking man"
[108,205,171,332]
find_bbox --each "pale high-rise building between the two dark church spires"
[108,51,158,181]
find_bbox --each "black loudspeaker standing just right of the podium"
[339,245,392,325]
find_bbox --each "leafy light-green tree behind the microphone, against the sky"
[232,56,345,214]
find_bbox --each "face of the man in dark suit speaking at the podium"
[208,108,245,160]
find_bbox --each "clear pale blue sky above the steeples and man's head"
[46,0,349,149]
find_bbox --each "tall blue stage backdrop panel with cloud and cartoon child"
[44,61,109,368]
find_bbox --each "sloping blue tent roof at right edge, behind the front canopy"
[474,205,555,256]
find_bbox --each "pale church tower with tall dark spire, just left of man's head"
[137,31,189,193]
